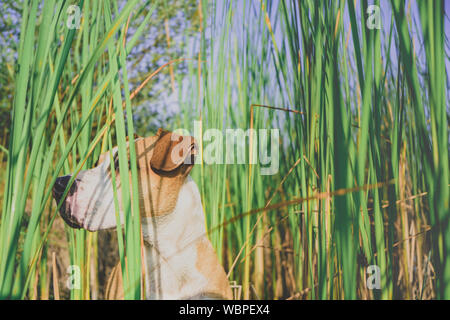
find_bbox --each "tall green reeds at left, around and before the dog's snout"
[0,1,148,299]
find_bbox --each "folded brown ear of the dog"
[150,129,197,173]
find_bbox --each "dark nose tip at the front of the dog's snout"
[52,175,81,229]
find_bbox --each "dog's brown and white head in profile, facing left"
[53,129,197,231]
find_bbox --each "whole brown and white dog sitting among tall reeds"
[53,129,232,299]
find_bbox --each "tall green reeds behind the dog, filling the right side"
[180,1,450,299]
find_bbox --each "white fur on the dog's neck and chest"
[142,177,215,299]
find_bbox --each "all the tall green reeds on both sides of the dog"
[0,0,450,299]
